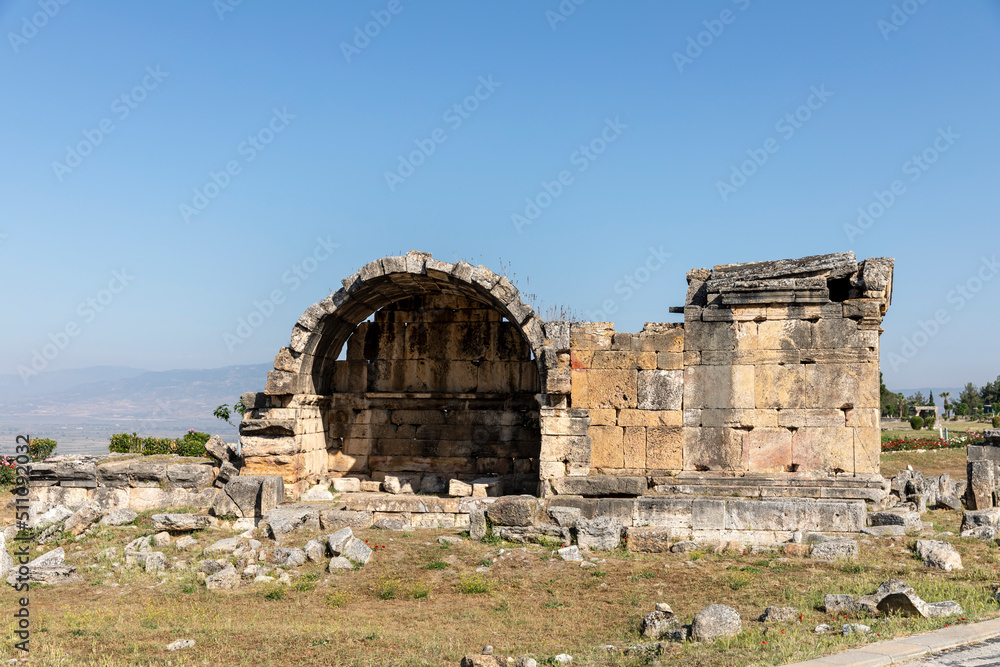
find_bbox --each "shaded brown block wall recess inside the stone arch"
[322,294,541,494]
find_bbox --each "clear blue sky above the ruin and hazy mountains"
[0,0,1000,389]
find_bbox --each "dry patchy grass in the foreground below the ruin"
[0,508,1000,667]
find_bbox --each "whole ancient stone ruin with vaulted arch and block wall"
[221,252,893,539]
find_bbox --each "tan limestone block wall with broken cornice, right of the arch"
[560,253,892,481]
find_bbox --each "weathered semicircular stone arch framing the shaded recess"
[247,251,589,497]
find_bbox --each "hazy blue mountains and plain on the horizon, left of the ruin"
[0,364,272,453]
